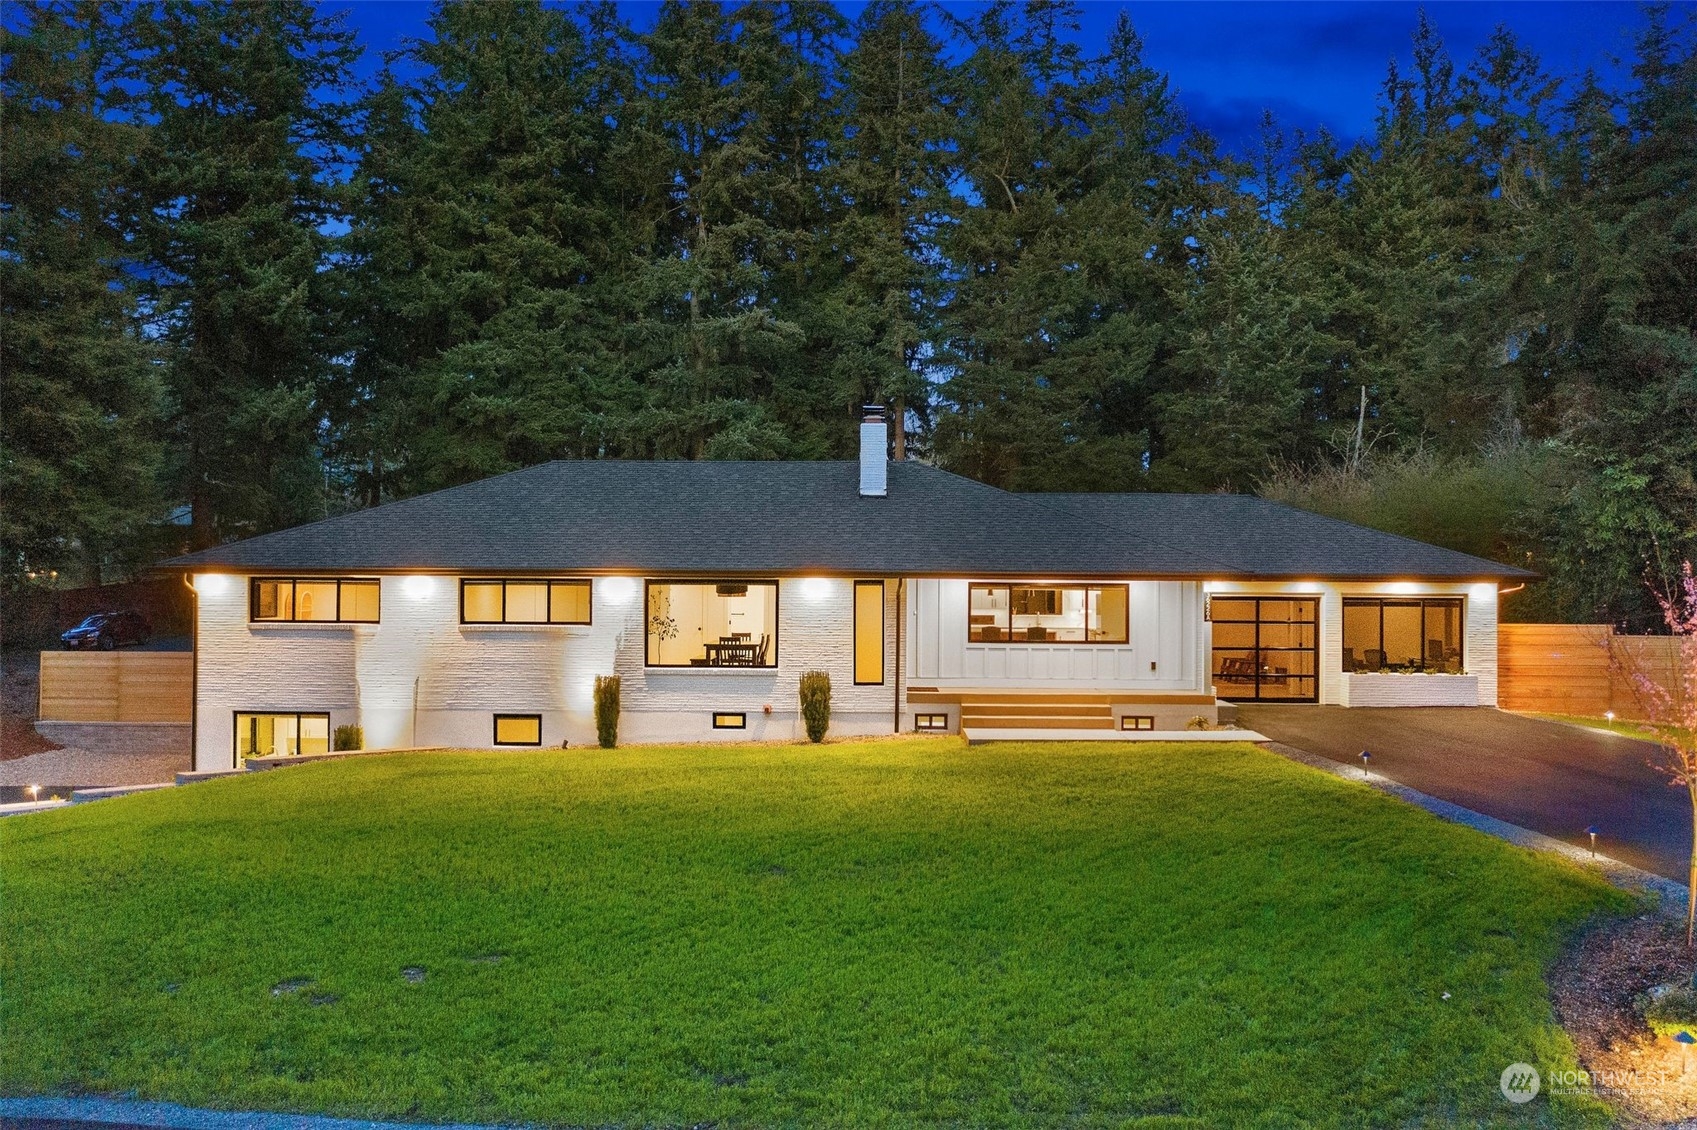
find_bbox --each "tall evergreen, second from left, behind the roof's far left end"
[127,0,356,545]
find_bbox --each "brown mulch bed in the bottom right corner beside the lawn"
[1544,915,1697,1128]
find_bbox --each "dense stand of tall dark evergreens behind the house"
[0,0,1697,626]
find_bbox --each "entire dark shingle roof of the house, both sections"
[163,460,1540,577]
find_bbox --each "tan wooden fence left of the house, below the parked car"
[37,652,195,723]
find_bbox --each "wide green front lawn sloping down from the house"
[0,740,1626,1128]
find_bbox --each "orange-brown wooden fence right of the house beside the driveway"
[1497,624,1680,718]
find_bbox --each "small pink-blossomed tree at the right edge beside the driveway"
[1609,562,1697,945]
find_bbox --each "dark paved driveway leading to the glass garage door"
[1237,704,1692,882]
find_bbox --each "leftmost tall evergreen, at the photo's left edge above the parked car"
[0,2,158,584]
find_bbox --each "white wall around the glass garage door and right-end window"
[1207,580,1497,706]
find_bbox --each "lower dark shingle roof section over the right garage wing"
[1028,494,1537,580]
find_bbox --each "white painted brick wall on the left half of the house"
[195,577,894,770]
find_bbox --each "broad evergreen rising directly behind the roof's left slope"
[336,3,631,497]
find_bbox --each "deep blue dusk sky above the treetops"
[334,0,1669,149]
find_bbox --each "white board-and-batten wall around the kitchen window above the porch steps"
[906,579,1207,694]
